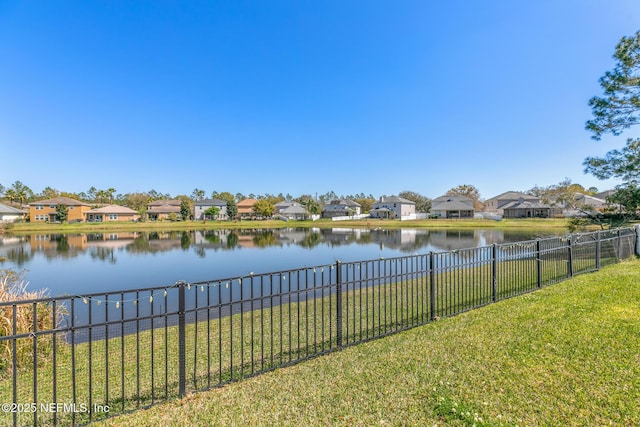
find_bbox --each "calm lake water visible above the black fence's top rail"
[0,228,566,296]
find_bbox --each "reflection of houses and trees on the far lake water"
[0,228,563,266]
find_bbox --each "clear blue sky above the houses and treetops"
[0,0,640,198]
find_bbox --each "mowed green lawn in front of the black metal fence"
[95,260,640,426]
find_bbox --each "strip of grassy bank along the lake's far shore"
[6,218,569,234]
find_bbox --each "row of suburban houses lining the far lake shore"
[0,191,608,222]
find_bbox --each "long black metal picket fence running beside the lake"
[0,228,638,425]
